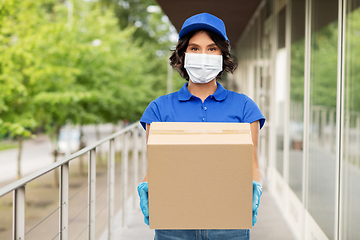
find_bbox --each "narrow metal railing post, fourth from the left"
[108,139,115,240]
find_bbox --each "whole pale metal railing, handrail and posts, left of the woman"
[0,122,147,240]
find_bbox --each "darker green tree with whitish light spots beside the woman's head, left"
[99,0,184,93]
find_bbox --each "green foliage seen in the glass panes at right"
[290,9,360,116]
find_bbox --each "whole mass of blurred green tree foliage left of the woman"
[0,0,171,140]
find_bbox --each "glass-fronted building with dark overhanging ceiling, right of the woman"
[158,0,360,240]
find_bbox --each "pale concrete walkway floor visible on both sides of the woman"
[108,183,295,240]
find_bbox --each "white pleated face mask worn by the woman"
[184,53,223,83]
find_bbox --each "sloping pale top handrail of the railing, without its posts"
[0,121,139,197]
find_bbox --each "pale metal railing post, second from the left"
[59,163,69,240]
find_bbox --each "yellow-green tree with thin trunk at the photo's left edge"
[0,0,50,178]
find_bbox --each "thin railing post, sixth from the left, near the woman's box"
[131,127,139,210]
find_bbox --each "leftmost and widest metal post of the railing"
[13,186,25,240]
